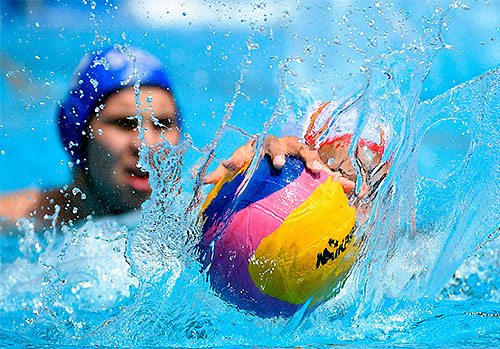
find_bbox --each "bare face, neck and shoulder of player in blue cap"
[0,86,180,227]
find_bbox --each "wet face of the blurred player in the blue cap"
[87,87,180,212]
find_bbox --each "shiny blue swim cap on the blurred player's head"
[58,46,176,168]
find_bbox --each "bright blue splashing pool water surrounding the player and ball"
[0,2,500,348]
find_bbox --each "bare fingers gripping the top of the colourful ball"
[205,136,324,184]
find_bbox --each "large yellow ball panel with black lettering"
[248,178,357,304]
